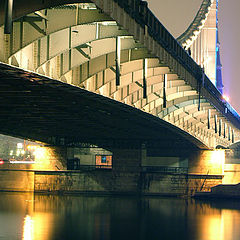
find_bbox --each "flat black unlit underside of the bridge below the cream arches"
[0,64,206,150]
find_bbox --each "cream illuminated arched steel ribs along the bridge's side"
[0,3,239,148]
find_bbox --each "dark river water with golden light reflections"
[0,193,240,240]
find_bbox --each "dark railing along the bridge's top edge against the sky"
[114,0,240,127]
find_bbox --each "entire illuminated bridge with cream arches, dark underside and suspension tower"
[0,0,240,195]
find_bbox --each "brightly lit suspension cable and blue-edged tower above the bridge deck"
[177,0,223,93]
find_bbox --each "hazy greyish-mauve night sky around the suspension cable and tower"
[147,0,240,113]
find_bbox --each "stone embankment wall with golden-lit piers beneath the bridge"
[0,147,229,196]
